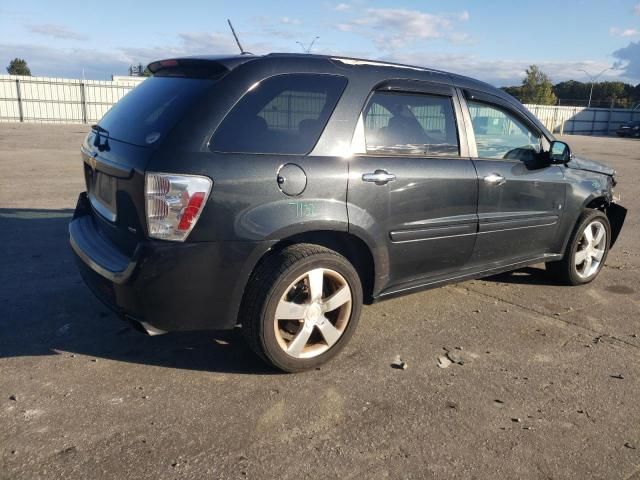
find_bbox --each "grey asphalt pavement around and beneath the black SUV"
[0,124,640,480]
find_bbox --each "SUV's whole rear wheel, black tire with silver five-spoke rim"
[239,244,362,372]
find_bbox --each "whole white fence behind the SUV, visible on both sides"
[0,75,640,135]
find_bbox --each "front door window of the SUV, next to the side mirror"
[467,101,541,161]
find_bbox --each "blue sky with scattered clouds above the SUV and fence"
[0,0,640,86]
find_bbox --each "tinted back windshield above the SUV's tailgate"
[99,77,215,146]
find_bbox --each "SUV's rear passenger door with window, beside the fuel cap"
[348,82,478,287]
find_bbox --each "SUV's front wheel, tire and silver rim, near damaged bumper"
[546,210,611,285]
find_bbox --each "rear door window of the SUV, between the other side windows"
[363,92,460,157]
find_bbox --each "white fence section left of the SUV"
[0,75,144,123]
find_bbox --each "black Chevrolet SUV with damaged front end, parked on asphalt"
[69,54,626,371]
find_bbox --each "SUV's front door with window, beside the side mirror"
[466,92,566,266]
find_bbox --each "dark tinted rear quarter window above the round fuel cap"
[209,74,347,155]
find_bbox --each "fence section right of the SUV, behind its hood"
[525,105,640,135]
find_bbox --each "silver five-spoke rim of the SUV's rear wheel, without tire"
[273,268,352,358]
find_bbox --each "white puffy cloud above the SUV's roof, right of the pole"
[337,8,469,52]
